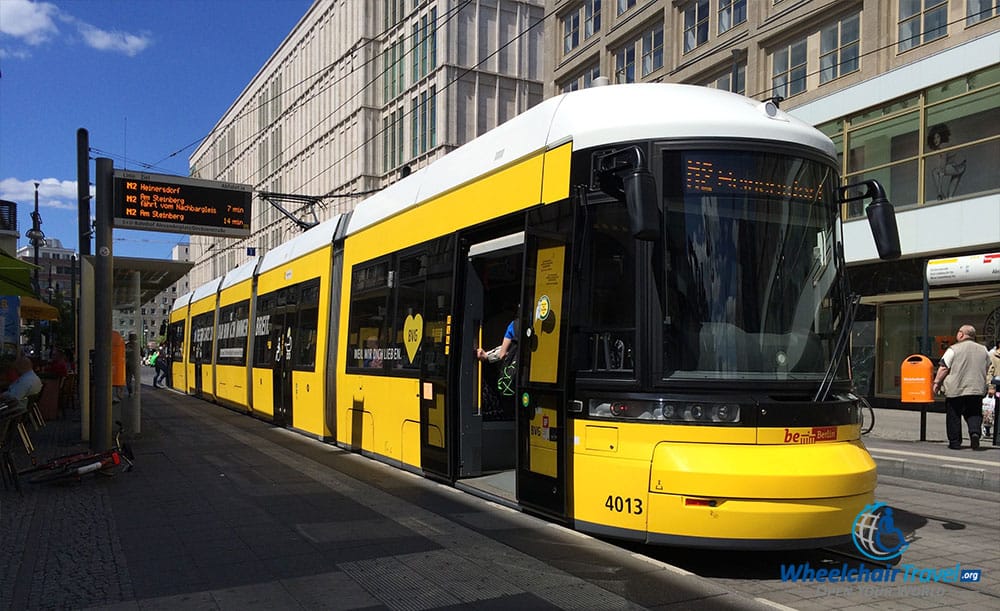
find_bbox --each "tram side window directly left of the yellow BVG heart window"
[345,258,390,372]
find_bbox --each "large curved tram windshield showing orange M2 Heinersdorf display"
[653,150,844,380]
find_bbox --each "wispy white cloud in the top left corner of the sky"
[0,0,153,59]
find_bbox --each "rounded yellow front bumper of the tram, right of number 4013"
[646,441,876,547]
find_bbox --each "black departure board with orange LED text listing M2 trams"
[114,170,253,238]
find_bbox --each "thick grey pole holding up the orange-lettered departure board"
[90,157,114,451]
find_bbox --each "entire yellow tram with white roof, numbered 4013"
[170,84,899,549]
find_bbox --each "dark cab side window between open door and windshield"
[572,203,636,377]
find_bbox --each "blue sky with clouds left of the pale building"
[0,0,312,258]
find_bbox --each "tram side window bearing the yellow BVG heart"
[387,249,427,372]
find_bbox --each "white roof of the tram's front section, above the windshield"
[348,83,836,237]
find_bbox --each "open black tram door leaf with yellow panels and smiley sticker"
[517,206,572,517]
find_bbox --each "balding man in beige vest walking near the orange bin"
[932,325,990,450]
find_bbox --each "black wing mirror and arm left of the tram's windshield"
[594,145,660,241]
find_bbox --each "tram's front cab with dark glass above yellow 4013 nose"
[572,141,898,549]
